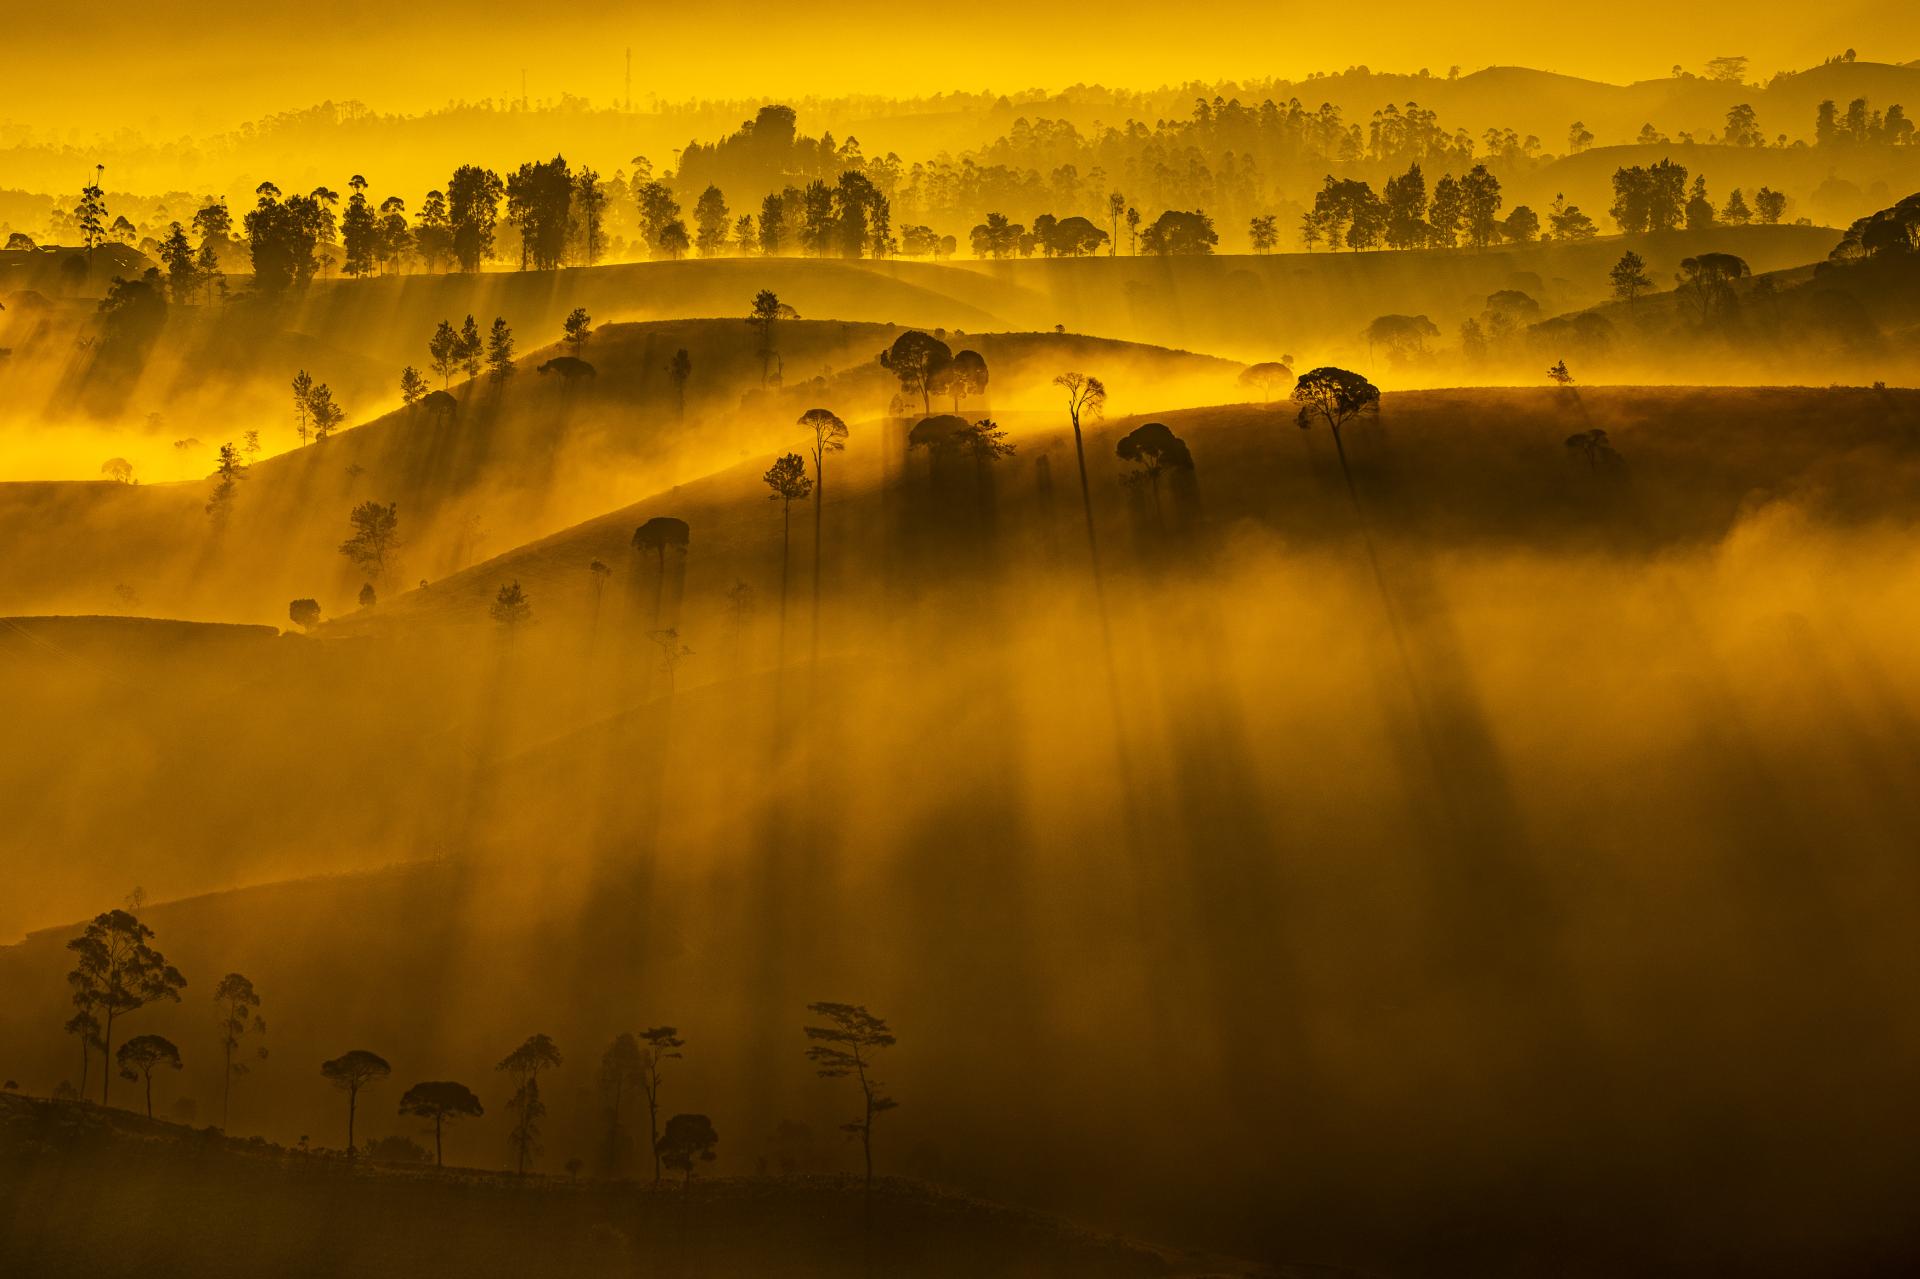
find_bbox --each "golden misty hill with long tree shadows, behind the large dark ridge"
[0,319,1238,622]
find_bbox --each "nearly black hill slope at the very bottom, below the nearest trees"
[0,1097,1290,1279]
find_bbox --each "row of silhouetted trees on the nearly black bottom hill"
[56,901,899,1195]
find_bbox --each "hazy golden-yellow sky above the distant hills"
[0,0,1920,131]
